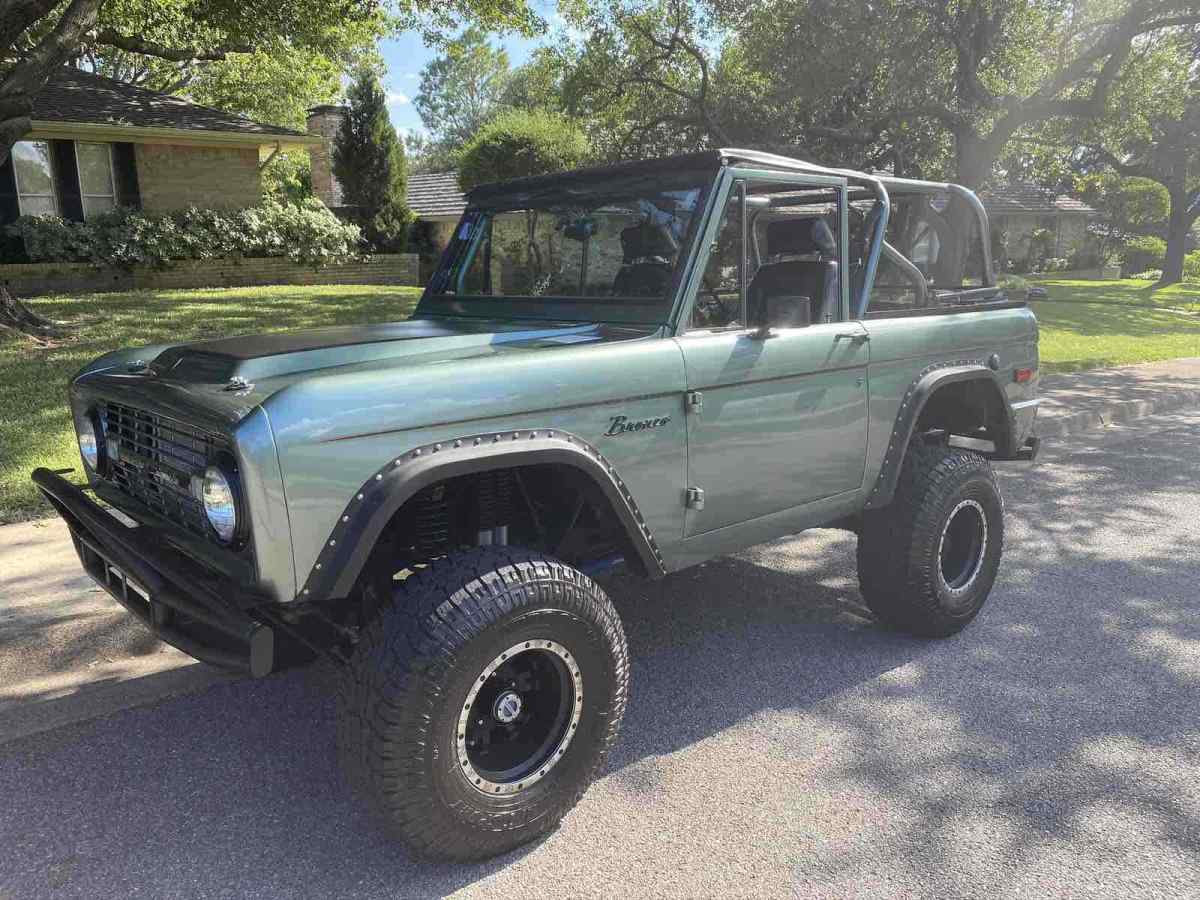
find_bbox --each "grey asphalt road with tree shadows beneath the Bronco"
[0,414,1200,900]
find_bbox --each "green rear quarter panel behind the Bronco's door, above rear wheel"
[863,306,1038,487]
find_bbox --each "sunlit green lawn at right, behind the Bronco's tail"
[1032,276,1200,372]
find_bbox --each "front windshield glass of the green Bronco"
[428,174,712,313]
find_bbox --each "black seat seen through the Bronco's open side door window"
[748,218,841,325]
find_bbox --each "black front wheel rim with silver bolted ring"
[456,641,583,794]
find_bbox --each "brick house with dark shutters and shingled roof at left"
[0,68,320,224]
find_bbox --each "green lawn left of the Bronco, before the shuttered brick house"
[0,284,420,523]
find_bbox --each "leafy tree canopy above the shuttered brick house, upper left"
[0,0,540,160]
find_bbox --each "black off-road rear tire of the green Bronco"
[858,436,1004,637]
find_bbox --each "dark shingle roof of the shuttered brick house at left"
[30,66,305,138]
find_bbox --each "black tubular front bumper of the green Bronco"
[31,469,275,678]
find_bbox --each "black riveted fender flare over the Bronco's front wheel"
[296,428,666,601]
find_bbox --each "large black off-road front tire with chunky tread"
[337,547,629,860]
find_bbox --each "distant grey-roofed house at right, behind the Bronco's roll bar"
[979,184,1099,262]
